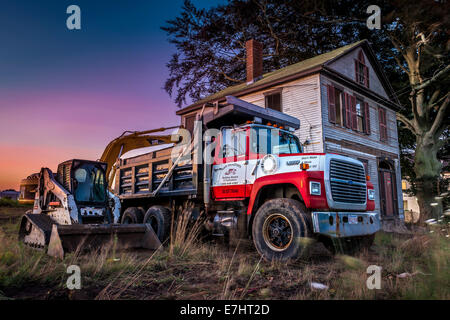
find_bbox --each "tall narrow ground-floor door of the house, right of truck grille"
[378,160,398,217]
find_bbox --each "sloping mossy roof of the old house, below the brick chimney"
[176,40,400,115]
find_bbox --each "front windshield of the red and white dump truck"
[250,127,302,154]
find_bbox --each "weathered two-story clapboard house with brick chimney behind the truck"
[177,40,403,229]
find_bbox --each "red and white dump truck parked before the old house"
[114,97,380,260]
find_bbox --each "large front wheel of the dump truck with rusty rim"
[252,198,312,261]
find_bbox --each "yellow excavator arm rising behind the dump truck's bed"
[100,126,180,185]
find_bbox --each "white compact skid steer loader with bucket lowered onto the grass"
[19,159,161,259]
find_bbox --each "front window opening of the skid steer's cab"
[74,163,106,203]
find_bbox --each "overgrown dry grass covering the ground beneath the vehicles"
[0,207,450,300]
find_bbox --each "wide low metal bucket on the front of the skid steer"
[47,224,161,259]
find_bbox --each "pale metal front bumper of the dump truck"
[312,212,380,238]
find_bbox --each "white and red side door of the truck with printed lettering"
[212,128,247,200]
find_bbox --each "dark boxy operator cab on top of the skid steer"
[57,159,107,207]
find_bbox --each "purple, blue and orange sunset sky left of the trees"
[0,0,225,190]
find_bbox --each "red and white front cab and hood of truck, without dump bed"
[211,121,380,257]
